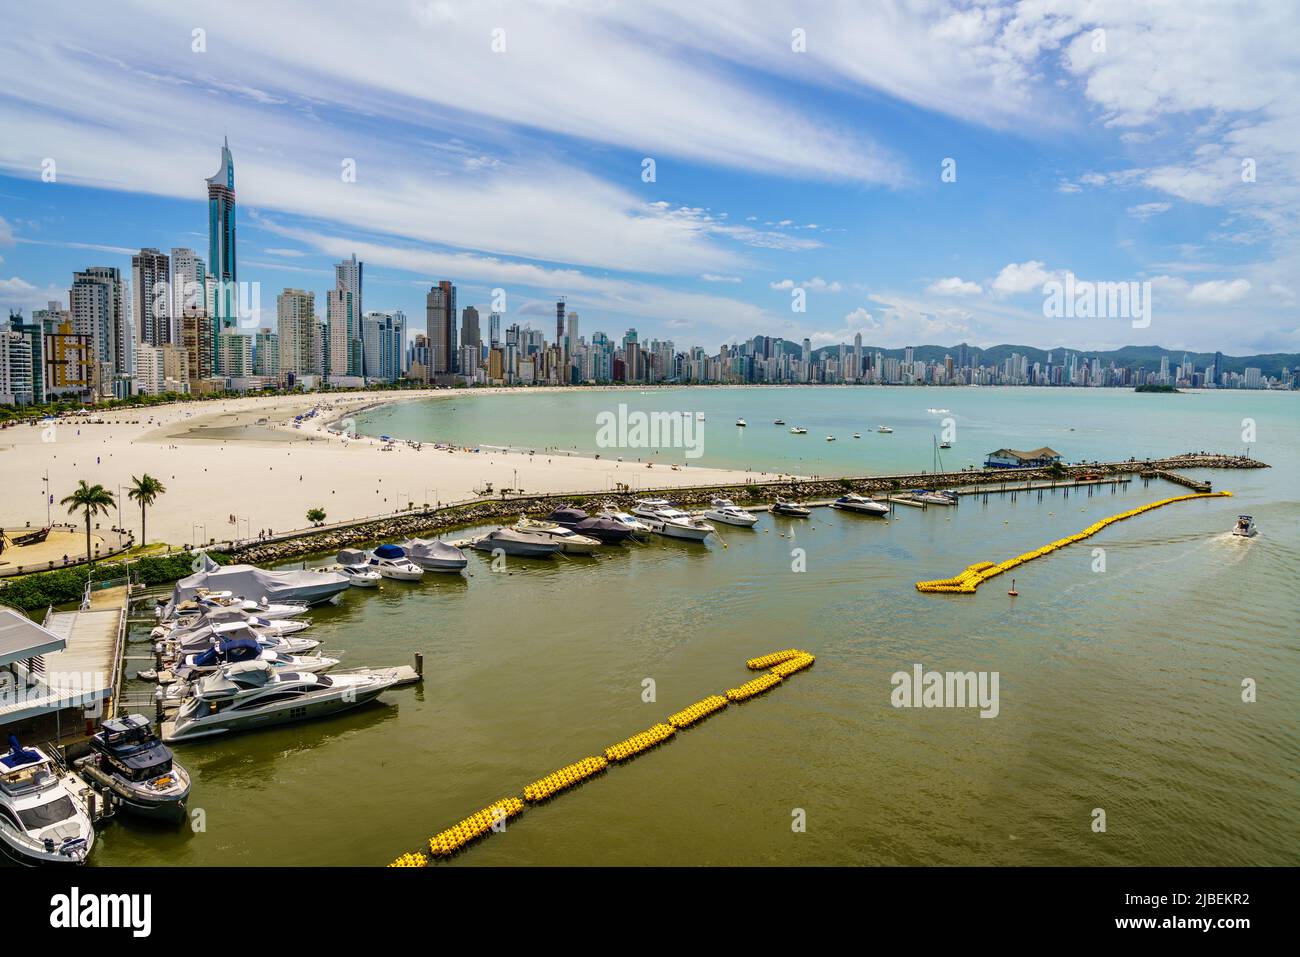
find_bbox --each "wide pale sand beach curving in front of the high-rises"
[0,389,780,545]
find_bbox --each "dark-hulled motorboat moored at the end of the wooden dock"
[75,714,190,824]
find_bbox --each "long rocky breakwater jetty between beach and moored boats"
[226,452,1269,564]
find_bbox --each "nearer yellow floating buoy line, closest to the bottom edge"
[389,648,816,867]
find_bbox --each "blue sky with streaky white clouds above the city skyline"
[0,0,1300,355]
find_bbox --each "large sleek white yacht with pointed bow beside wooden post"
[163,661,398,742]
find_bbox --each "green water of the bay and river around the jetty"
[92,389,1300,866]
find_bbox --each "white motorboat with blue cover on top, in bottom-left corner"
[0,735,95,865]
